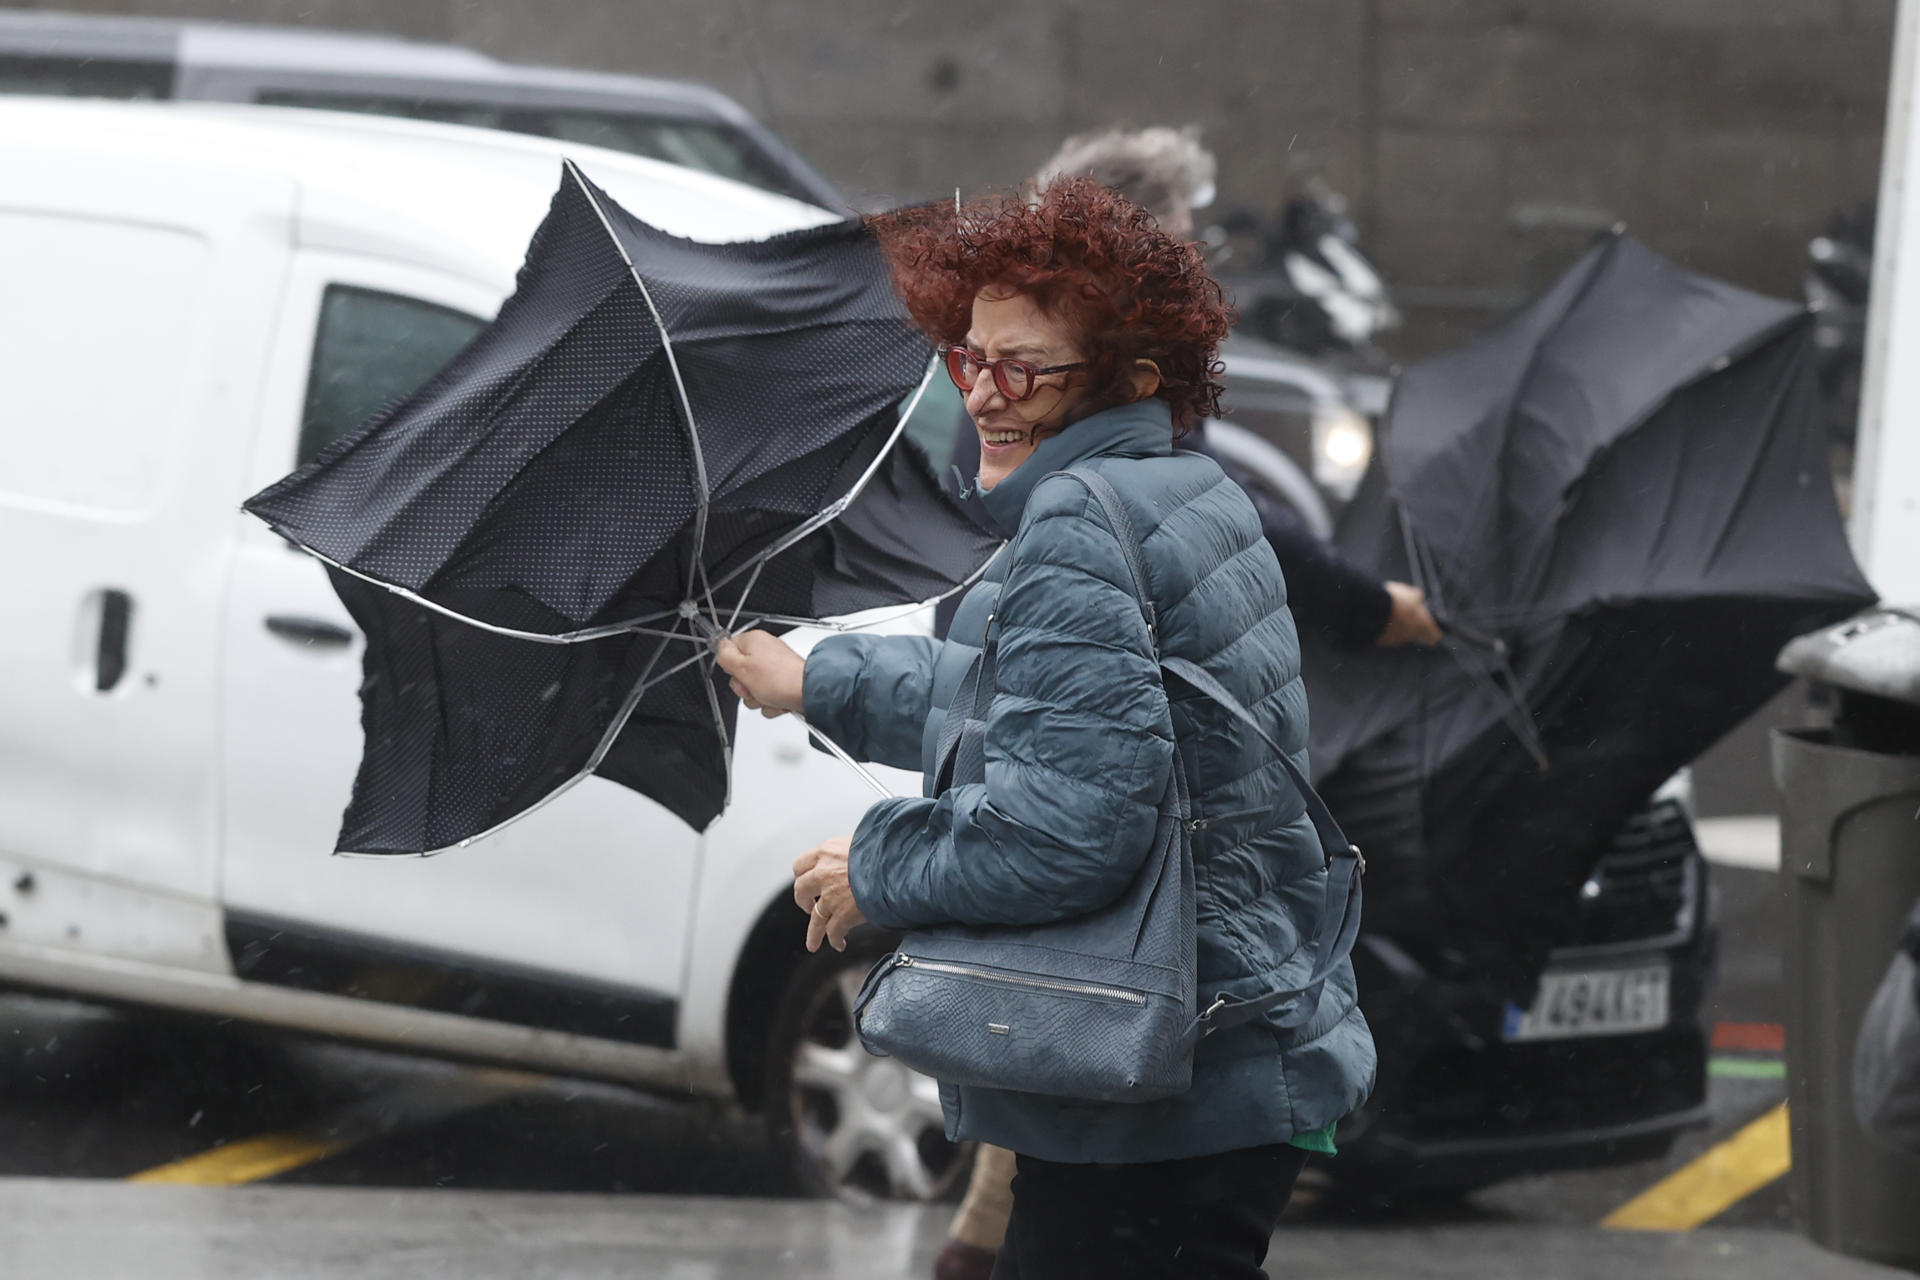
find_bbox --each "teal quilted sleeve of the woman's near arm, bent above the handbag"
[851,478,1173,929]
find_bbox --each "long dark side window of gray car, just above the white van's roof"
[255,90,820,203]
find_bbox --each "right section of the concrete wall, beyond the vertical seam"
[1367,0,1893,351]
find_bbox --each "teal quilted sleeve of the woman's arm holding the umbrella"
[803,635,941,770]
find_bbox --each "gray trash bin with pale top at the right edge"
[1774,608,1920,1268]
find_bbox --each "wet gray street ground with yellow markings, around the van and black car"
[0,867,1893,1280]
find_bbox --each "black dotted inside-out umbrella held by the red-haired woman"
[246,163,995,852]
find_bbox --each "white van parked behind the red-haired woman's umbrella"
[0,98,962,1197]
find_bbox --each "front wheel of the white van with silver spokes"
[766,938,973,1203]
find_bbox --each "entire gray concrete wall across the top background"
[13,0,1895,345]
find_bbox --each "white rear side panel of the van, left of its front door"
[0,142,294,958]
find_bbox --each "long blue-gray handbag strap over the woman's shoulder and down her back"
[1059,470,1367,1036]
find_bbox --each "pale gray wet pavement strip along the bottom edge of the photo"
[0,1178,1905,1280]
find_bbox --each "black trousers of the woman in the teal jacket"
[993,1146,1308,1280]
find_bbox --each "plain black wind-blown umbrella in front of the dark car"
[1308,236,1872,1000]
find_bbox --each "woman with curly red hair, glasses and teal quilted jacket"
[720,178,1373,1280]
